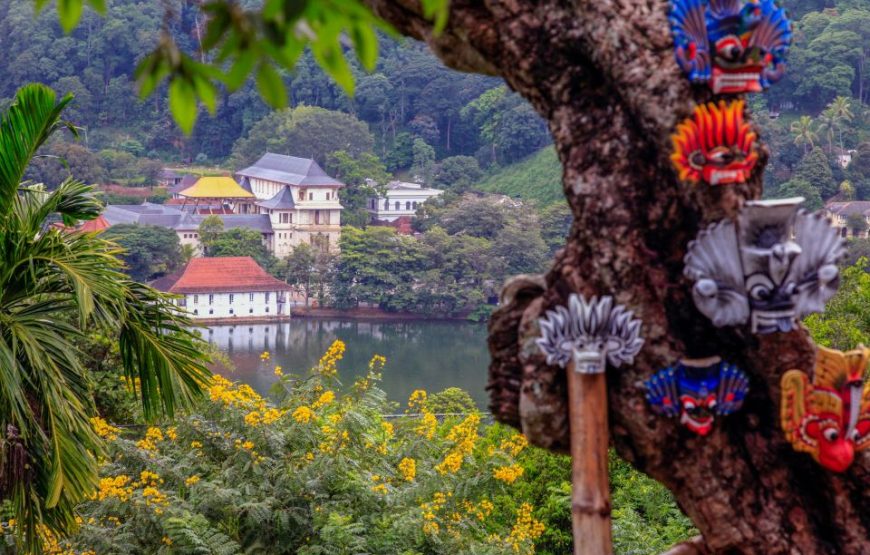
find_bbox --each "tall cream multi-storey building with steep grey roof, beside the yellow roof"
[236,152,344,258]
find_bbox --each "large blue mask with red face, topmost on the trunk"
[668,0,791,94]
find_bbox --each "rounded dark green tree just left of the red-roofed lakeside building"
[103,224,183,283]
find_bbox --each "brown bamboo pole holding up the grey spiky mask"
[566,360,613,555]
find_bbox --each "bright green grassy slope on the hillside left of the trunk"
[474,146,565,206]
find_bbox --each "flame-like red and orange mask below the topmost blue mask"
[671,100,758,185]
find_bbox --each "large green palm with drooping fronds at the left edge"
[0,85,209,553]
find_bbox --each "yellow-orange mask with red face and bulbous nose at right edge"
[781,346,870,472]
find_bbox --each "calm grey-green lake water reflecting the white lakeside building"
[203,318,489,408]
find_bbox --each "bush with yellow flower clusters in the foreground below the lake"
[4,342,696,555]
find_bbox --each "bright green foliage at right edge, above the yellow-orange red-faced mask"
[804,258,870,350]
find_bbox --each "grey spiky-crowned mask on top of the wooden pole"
[536,294,643,374]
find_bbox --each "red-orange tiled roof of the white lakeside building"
[169,256,290,293]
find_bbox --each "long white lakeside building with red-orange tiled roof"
[152,256,291,320]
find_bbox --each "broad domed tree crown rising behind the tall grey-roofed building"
[232,106,374,168]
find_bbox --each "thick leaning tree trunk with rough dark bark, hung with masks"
[366,0,870,555]
